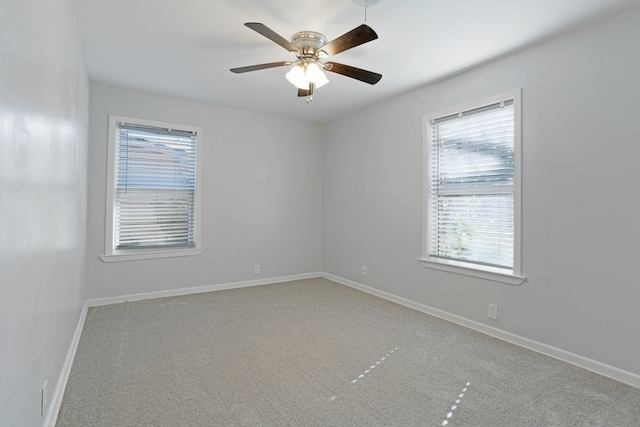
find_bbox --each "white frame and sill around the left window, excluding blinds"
[100,115,204,262]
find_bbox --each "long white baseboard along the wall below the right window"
[322,273,640,388]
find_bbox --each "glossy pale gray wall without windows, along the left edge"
[0,0,89,426]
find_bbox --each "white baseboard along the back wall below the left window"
[87,272,322,307]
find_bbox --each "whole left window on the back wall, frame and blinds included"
[101,116,202,262]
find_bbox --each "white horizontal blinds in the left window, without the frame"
[114,123,196,249]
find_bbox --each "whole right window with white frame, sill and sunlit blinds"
[421,91,524,284]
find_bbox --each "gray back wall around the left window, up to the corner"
[87,84,322,298]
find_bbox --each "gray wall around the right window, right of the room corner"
[323,8,640,374]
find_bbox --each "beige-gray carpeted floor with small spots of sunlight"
[56,279,640,427]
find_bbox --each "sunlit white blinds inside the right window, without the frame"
[428,100,515,268]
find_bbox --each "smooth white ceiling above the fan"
[73,0,640,123]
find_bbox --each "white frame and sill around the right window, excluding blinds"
[419,89,526,285]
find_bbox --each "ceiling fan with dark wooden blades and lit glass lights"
[230,22,382,100]
